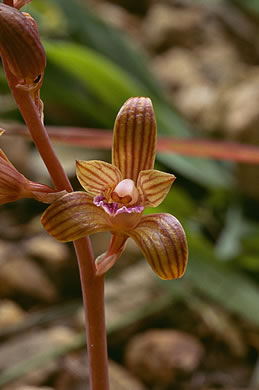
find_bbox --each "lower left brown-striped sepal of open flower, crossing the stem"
[41,192,109,242]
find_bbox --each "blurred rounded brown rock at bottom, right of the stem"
[125,330,204,385]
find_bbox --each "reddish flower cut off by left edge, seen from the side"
[0,129,66,204]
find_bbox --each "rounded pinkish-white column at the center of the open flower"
[111,179,139,206]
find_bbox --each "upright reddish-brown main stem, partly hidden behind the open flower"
[2,58,109,390]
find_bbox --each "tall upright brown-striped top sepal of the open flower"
[112,97,156,182]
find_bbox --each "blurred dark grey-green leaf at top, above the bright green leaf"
[49,0,167,98]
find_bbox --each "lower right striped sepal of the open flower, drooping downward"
[127,213,188,279]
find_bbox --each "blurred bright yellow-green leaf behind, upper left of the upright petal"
[44,42,145,110]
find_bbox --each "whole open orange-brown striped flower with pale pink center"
[42,97,188,279]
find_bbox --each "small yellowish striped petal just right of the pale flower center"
[137,169,176,207]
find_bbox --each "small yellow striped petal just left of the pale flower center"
[76,160,121,196]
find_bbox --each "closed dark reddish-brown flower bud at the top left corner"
[0,1,46,89]
